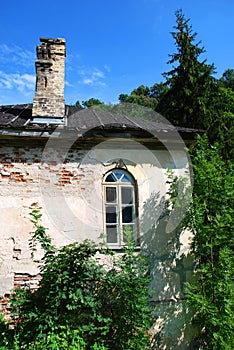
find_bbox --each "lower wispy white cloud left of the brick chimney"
[0,71,35,92]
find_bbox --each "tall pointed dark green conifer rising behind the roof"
[158,10,216,129]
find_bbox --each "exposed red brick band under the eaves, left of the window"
[0,147,91,193]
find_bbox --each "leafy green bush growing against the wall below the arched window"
[1,208,150,350]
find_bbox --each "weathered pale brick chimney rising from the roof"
[32,38,66,122]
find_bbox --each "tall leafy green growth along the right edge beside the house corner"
[187,137,234,350]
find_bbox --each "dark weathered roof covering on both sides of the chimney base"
[0,104,199,138]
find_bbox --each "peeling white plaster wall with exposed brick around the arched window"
[0,139,197,349]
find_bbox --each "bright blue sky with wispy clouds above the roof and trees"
[0,0,234,105]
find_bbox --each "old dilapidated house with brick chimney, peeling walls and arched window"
[0,38,199,349]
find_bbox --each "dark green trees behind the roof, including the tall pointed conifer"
[73,10,234,145]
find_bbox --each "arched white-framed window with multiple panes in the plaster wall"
[103,169,137,246]
